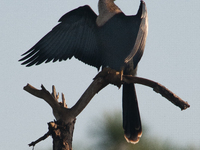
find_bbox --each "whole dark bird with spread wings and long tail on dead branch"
[20,0,148,143]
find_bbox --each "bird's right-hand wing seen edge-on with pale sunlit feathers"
[125,1,148,68]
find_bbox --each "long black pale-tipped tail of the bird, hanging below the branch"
[122,83,142,144]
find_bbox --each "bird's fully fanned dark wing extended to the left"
[20,6,100,68]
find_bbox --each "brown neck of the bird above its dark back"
[96,0,121,26]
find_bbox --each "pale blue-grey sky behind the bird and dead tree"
[0,0,200,150]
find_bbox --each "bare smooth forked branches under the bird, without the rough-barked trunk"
[24,68,190,123]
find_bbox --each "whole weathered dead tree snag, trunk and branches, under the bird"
[24,68,190,150]
